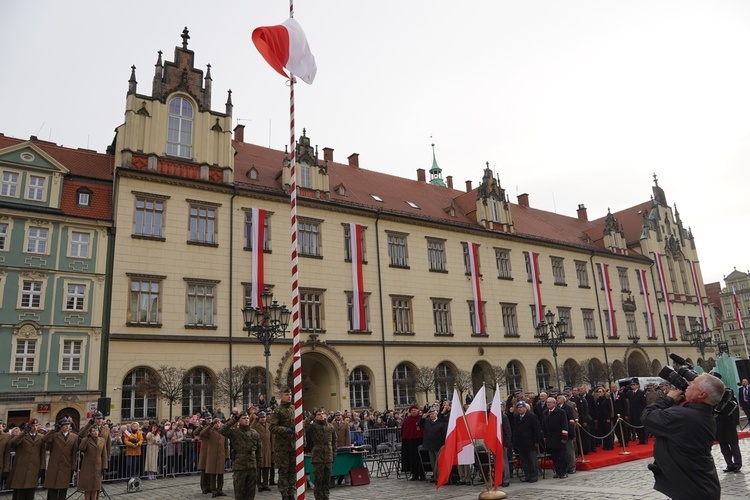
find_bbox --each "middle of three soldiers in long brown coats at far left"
[42,417,78,500]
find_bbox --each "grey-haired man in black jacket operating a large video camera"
[641,373,724,500]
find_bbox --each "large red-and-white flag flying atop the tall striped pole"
[252,17,318,85]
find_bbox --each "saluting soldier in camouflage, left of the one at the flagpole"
[219,412,262,500]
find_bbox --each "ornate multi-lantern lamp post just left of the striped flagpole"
[247,288,292,398]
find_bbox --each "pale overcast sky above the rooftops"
[0,0,750,283]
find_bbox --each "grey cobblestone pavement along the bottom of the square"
[0,439,750,500]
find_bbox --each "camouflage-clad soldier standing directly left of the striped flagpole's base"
[271,387,297,500]
